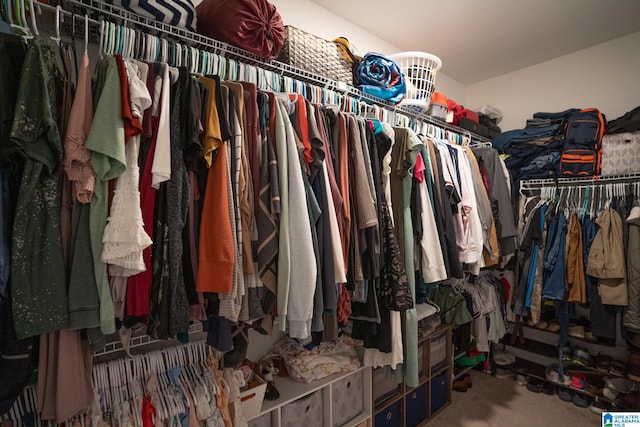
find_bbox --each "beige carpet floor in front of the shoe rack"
[429,370,602,427]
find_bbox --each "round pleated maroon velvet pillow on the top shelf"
[196,0,284,59]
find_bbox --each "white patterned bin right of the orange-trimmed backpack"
[601,132,640,176]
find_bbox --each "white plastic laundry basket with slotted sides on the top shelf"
[389,51,442,112]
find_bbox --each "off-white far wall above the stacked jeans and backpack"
[464,32,640,131]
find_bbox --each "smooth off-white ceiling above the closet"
[312,0,640,85]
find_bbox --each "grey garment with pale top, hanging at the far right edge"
[622,206,640,332]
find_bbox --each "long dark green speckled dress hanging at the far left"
[11,36,69,339]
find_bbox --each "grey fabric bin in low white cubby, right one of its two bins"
[331,371,364,427]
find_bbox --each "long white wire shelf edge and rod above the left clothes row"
[48,0,488,142]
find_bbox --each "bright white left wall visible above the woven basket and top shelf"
[270,0,465,104]
